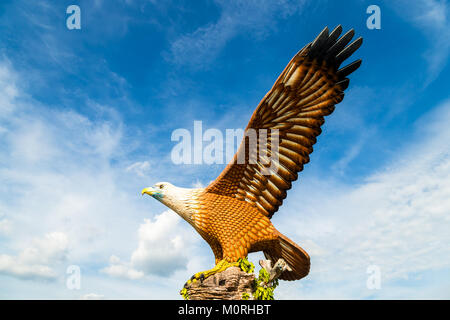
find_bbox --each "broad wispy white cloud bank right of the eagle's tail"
[274,102,450,299]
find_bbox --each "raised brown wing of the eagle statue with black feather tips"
[206,26,362,217]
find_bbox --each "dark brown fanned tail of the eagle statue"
[264,233,310,280]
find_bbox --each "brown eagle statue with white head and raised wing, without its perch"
[142,25,362,281]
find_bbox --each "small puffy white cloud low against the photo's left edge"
[0,232,68,280]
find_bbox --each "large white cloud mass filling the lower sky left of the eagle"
[0,57,207,298]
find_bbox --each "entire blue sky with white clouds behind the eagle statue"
[0,0,450,299]
